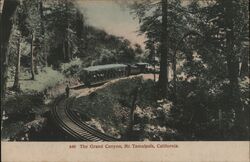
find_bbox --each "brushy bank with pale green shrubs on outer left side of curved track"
[1,67,78,141]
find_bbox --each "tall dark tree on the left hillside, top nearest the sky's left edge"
[45,0,80,63]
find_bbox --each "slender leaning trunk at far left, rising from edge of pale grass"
[13,38,21,91]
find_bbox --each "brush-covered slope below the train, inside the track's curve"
[70,76,178,141]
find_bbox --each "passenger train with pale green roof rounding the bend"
[80,63,149,86]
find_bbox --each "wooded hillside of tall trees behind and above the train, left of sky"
[1,0,143,93]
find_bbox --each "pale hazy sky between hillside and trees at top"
[77,0,145,47]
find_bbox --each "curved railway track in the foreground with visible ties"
[51,95,119,141]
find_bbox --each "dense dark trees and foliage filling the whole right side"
[131,0,249,139]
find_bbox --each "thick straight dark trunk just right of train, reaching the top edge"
[159,0,168,98]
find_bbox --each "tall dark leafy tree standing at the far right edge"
[186,0,249,125]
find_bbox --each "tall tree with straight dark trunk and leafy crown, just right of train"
[132,0,193,98]
